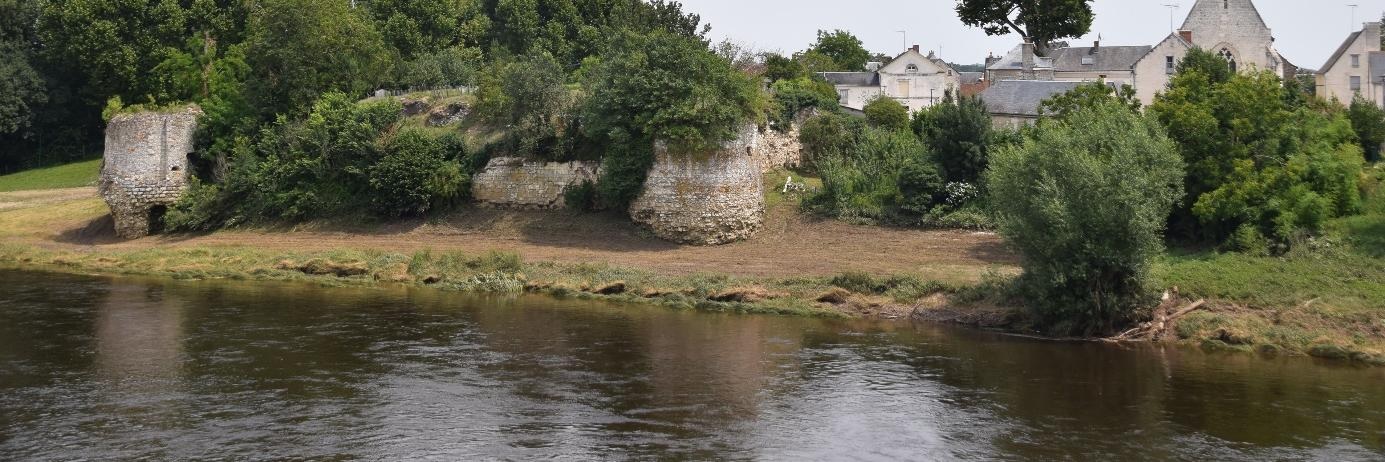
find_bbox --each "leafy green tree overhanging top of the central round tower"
[583,32,766,209]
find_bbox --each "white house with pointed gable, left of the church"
[817,46,961,112]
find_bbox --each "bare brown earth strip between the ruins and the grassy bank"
[0,188,1015,282]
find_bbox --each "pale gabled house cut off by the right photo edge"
[1314,22,1385,107]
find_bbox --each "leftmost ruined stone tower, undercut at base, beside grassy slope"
[100,107,202,239]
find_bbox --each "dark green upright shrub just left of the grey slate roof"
[915,91,992,184]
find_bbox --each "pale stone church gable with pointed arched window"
[1183,0,1292,75]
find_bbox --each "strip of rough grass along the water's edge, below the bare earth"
[0,243,997,318]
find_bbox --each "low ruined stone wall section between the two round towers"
[471,158,601,209]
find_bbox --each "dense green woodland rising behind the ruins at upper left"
[0,0,706,172]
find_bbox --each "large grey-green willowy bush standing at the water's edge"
[986,102,1183,335]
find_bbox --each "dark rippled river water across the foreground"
[0,271,1385,461]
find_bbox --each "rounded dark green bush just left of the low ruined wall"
[370,129,468,217]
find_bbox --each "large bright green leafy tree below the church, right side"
[1150,66,1363,252]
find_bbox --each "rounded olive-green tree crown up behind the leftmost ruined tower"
[245,0,391,115]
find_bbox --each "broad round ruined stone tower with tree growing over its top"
[630,126,765,245]
